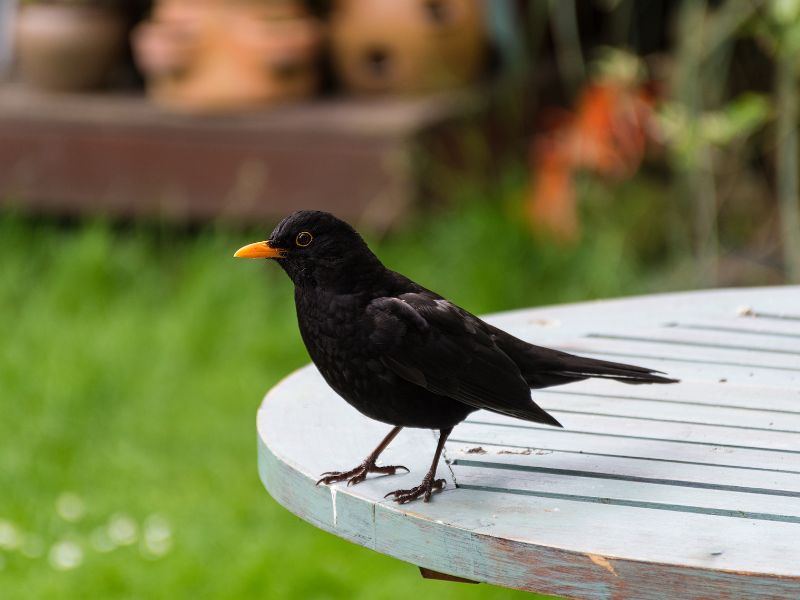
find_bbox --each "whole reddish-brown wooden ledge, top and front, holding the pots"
[0,87,522,228]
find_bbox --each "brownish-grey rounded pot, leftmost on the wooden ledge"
[16,4,125,91]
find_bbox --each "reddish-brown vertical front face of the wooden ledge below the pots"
[0,113,406,222]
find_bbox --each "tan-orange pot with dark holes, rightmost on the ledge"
[330,0,487,93]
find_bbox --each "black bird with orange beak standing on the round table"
[235,211,676,503]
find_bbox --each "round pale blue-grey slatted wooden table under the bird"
[258,287,800,599]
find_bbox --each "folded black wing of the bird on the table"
[367,292,559,425]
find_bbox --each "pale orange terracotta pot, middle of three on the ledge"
[133,0,320,111]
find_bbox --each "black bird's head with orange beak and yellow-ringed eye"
[234,210,380,285]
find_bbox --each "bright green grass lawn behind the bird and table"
[0,191,688,600]
